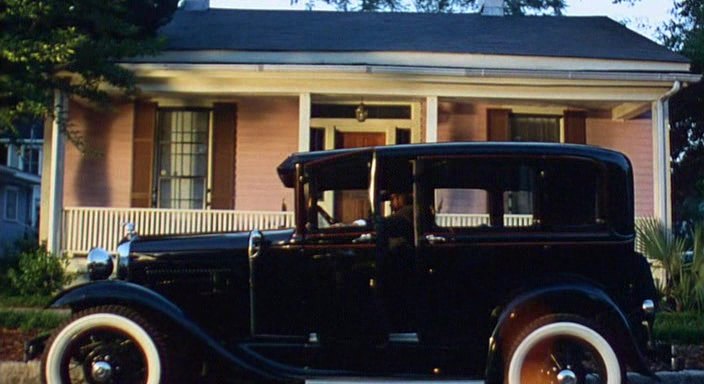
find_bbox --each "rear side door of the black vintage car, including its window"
[415,157,525,348]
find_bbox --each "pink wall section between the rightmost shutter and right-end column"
[587,118,653,216]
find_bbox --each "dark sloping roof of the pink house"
[160,9,689,63]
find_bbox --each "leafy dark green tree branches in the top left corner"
[0,0,178,134]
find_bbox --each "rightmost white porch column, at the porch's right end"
[652,99,672,228]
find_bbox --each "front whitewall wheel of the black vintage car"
[42,306,168,384]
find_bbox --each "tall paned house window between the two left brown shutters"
[156,110,210,209]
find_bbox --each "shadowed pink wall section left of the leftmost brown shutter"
[64,101,134,207]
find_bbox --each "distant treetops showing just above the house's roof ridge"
[292,0,565,15]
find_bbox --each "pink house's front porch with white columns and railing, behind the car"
[40,65,700,254]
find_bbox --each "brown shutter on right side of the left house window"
[210,103,237,209]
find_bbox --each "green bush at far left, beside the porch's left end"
[7,247,74,296]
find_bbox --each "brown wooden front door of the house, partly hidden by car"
[334,131,386,223]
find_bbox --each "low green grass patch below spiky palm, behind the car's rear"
[653,312,704,344]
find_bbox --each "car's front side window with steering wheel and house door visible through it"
[306,154,371,230]
